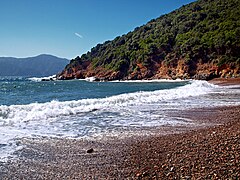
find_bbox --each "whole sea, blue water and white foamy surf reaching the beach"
[0,77,240,161]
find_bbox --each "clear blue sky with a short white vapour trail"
[0,0,194,59]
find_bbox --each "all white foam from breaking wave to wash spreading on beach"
[0,81,238,160]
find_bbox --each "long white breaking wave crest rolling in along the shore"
[0,81,215,125]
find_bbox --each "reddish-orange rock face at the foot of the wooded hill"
[58,59,240,81]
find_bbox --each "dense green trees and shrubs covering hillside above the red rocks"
[61,0,240,78]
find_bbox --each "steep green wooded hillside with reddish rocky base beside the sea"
[58,0,240,80]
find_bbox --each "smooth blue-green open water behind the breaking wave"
[0,77,188,105]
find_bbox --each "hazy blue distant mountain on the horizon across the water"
[0,54,69,77]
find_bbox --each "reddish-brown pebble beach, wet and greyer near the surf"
[0,77,240,179]
